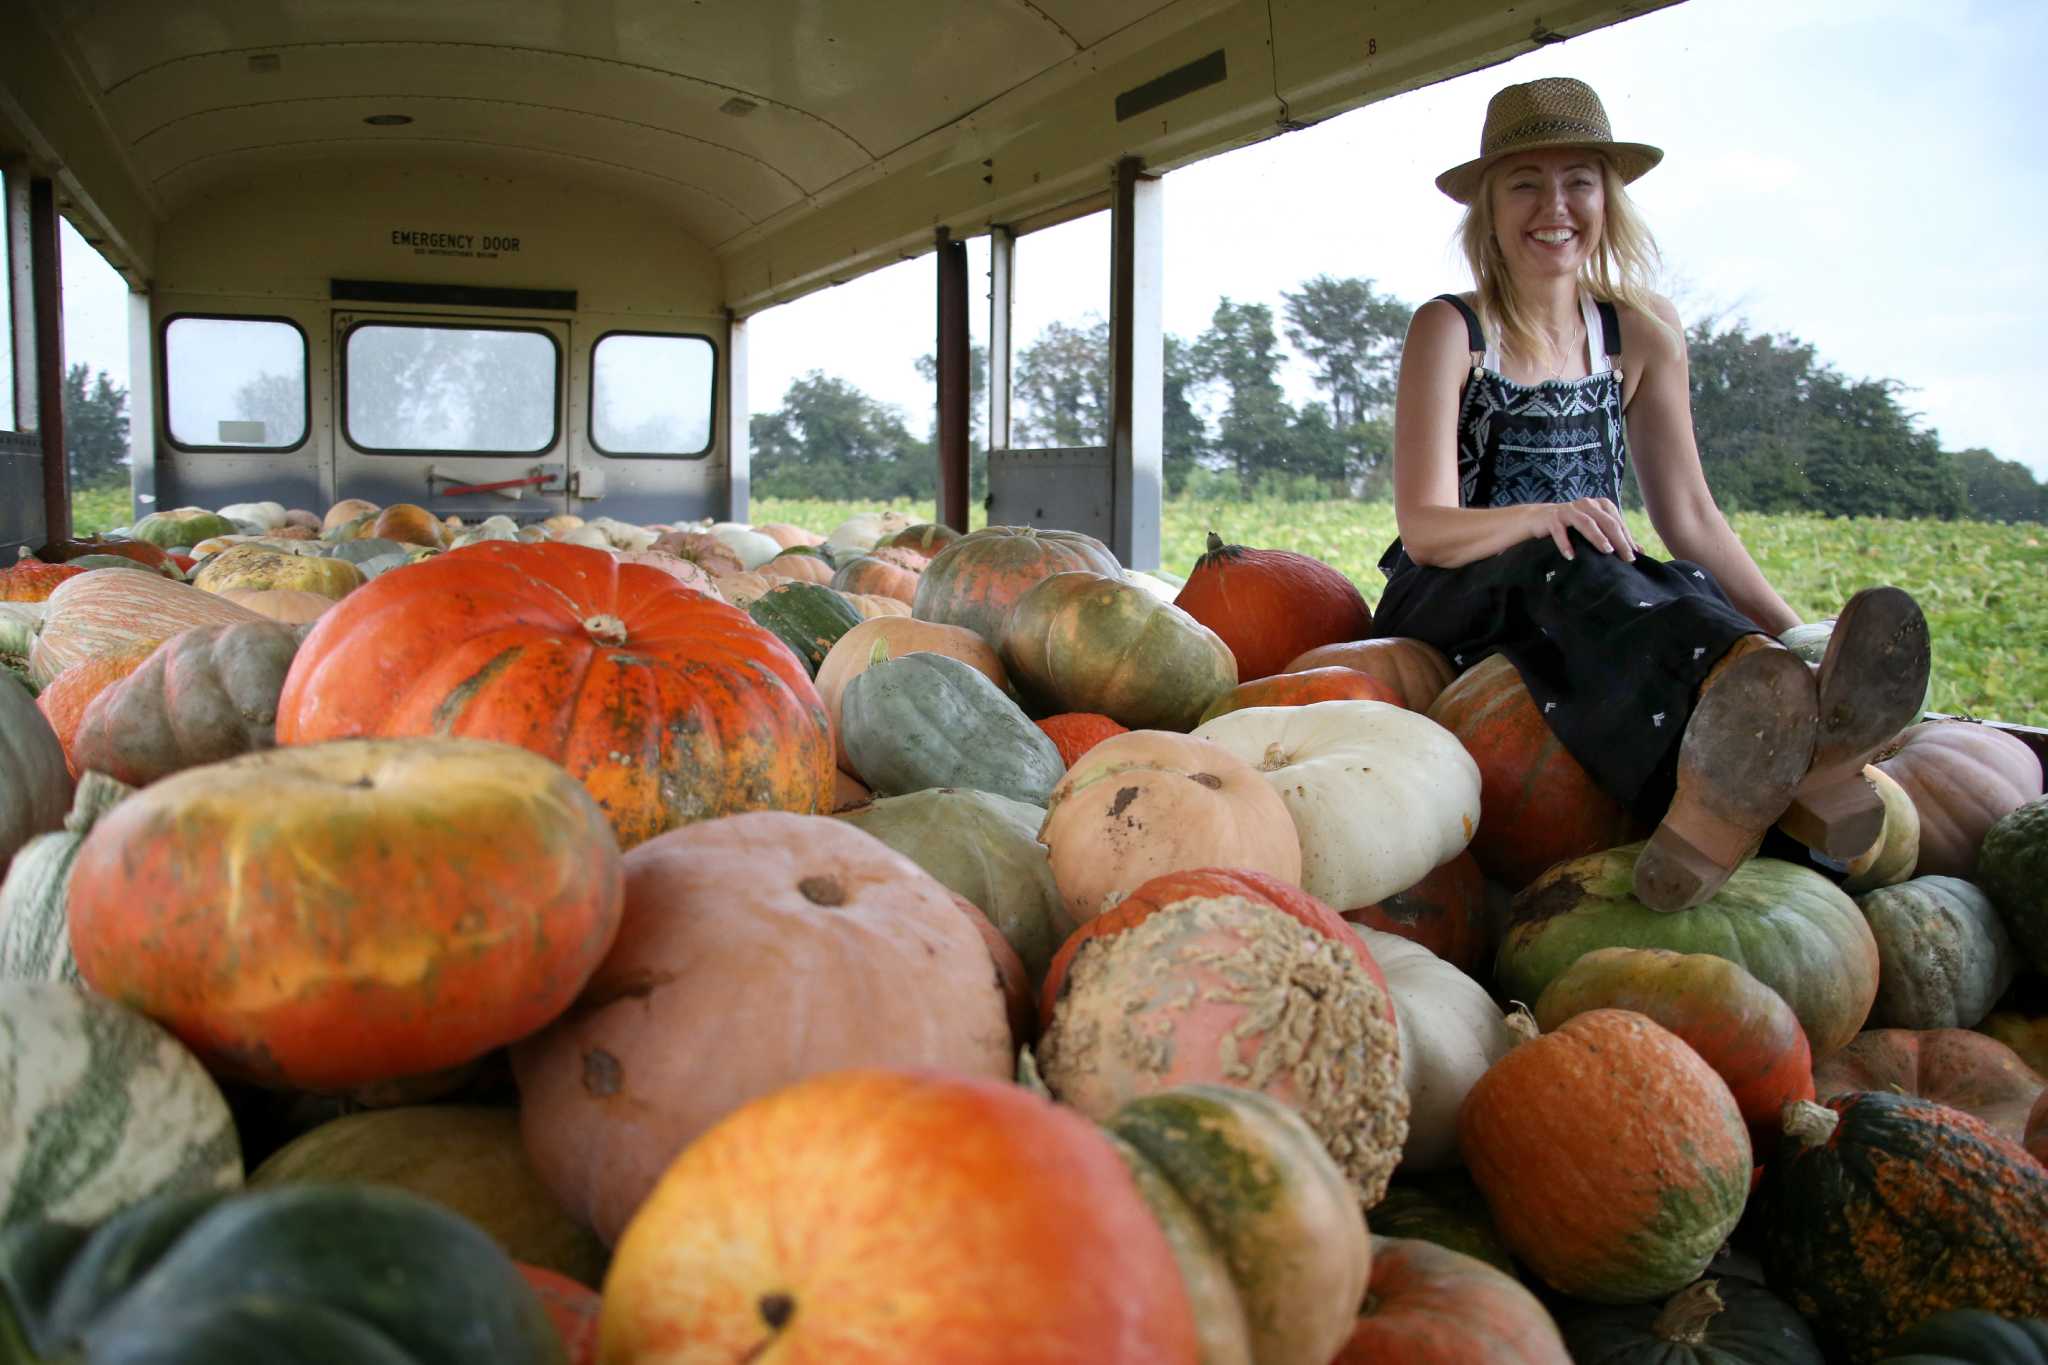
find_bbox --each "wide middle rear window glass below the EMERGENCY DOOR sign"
[344,323,561,454]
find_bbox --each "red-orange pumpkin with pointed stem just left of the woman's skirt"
[1174,532,1372,677]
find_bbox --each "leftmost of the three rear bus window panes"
[164,317,305,450]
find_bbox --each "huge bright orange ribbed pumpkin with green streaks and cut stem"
[276,540,831,847]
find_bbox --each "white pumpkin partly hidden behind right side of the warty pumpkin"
[1352,925,1516,1171]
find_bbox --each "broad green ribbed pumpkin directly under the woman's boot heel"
[1493,843,1878,1058]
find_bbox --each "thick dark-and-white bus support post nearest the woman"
[1110,158,1165,569]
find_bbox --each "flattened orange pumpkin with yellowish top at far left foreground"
[68,739,623,1091]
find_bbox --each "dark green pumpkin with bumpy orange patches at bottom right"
[1757,1091,2048,1361]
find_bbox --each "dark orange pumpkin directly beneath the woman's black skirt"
[1430,655,1647,890]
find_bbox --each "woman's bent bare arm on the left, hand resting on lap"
[1395,299,1636,569]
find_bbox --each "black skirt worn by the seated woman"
[1372,532,1759,819]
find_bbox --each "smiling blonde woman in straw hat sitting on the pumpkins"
[1374,78,1927,911]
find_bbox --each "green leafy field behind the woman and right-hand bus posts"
[752,499,2048,724]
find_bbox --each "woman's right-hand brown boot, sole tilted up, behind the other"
[1780,587,1931,862]
